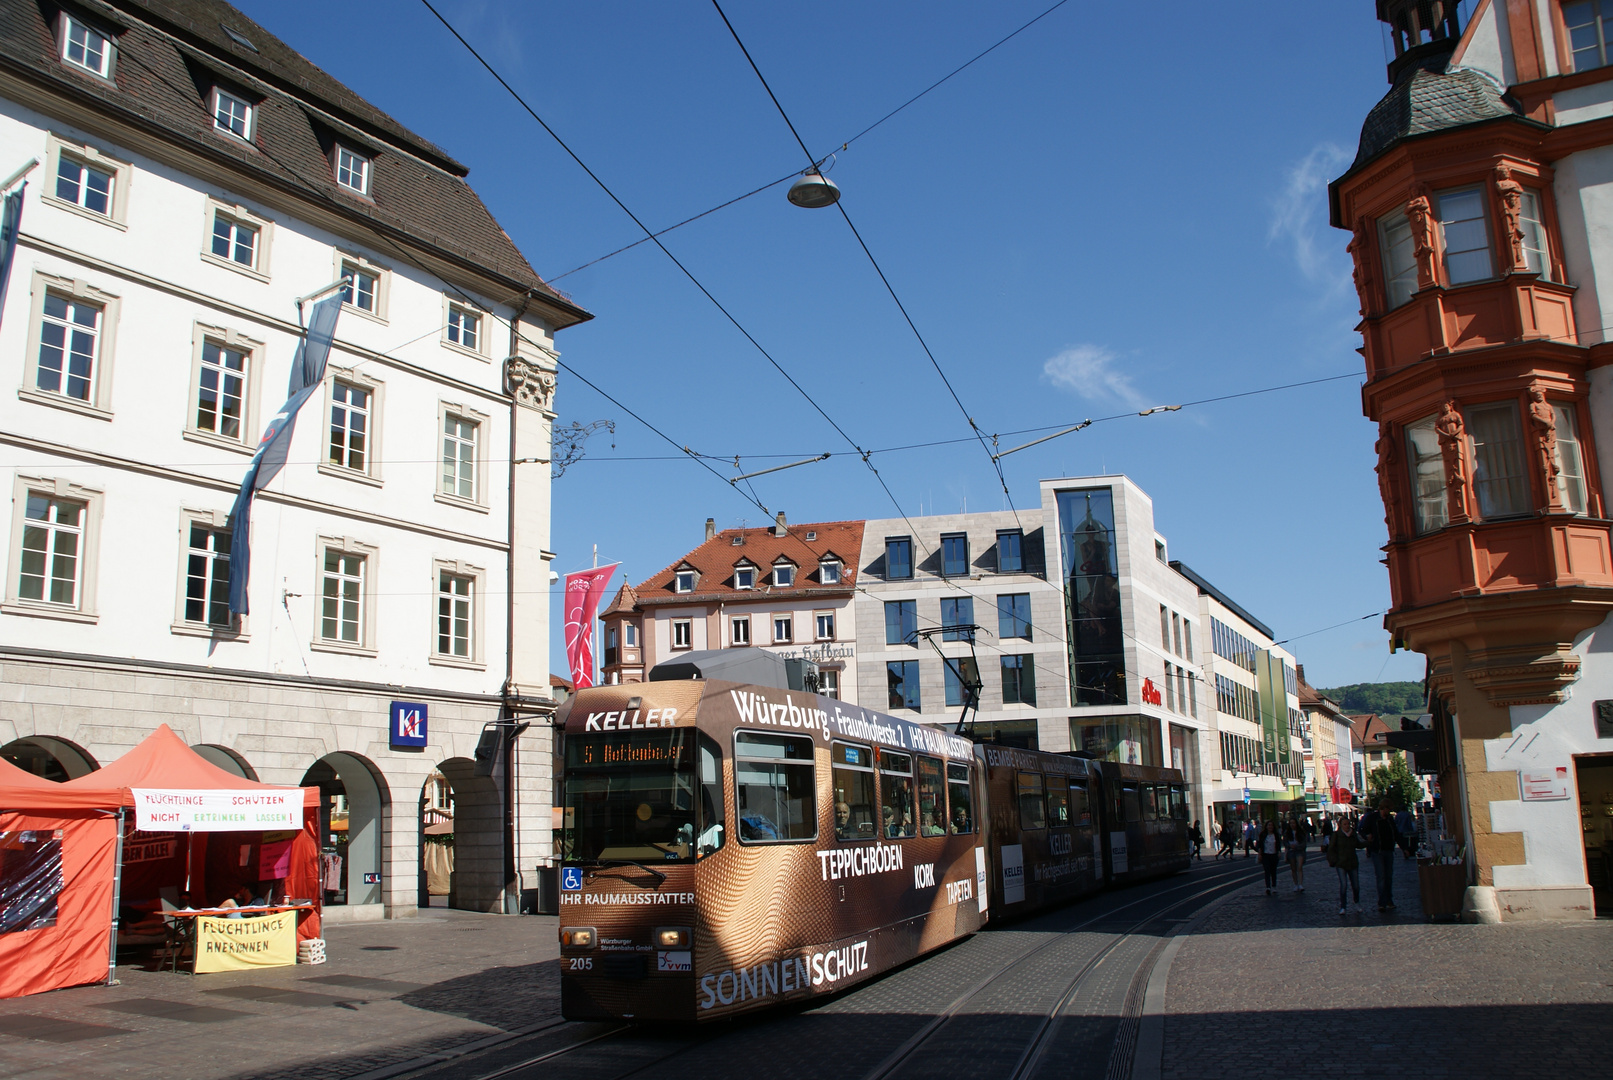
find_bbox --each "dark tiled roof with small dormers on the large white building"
[0,0,592,329]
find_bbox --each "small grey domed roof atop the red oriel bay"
[1350,52,1523,172]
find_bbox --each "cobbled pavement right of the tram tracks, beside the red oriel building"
[1163,853,1613,1080]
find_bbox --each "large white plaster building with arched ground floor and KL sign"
[0,0,589,917]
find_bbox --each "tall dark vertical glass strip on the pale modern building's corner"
[1058,487,1122,706]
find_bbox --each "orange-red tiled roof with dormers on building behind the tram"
[622,521,863,611]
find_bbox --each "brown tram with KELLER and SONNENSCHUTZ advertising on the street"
[560,679,1187,1022]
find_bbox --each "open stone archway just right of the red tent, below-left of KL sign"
[302,753,389,906]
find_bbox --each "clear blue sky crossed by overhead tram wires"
[237,0,1423,685]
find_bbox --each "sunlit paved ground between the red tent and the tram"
[0,909,560,1080]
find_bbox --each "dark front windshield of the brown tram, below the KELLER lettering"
[561,727,698,862]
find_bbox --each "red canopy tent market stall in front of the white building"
[0,724,321,998]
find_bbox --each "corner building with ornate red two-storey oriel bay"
[1329,0,1613,920]
